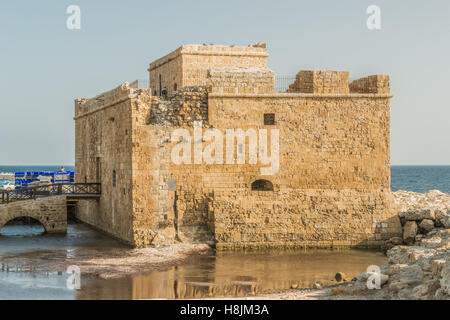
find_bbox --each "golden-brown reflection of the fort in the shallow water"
[78,250,386,299]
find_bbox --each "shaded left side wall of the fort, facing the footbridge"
[75,83,139,243]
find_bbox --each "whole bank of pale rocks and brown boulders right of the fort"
[339,191,450,300]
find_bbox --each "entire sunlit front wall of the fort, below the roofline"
[128,86,401,249]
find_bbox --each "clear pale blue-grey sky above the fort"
[0,0,450,165]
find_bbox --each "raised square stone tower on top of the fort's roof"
[148,43,268,96]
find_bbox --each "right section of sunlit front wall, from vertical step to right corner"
[209,94,401,248]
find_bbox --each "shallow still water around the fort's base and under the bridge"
[0,223,386,299]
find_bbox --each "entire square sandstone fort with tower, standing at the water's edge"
[74,43,401,250]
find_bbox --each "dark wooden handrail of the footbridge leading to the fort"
[0,183,102,204]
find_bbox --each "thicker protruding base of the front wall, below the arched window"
[211,189,401,249]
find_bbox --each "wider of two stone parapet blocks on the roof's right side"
[288,70,349,94]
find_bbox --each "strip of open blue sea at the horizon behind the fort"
[0,165,450,193]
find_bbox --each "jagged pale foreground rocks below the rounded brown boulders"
[339,229,450,300]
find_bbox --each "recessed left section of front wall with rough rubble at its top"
[133,87,213,247]
